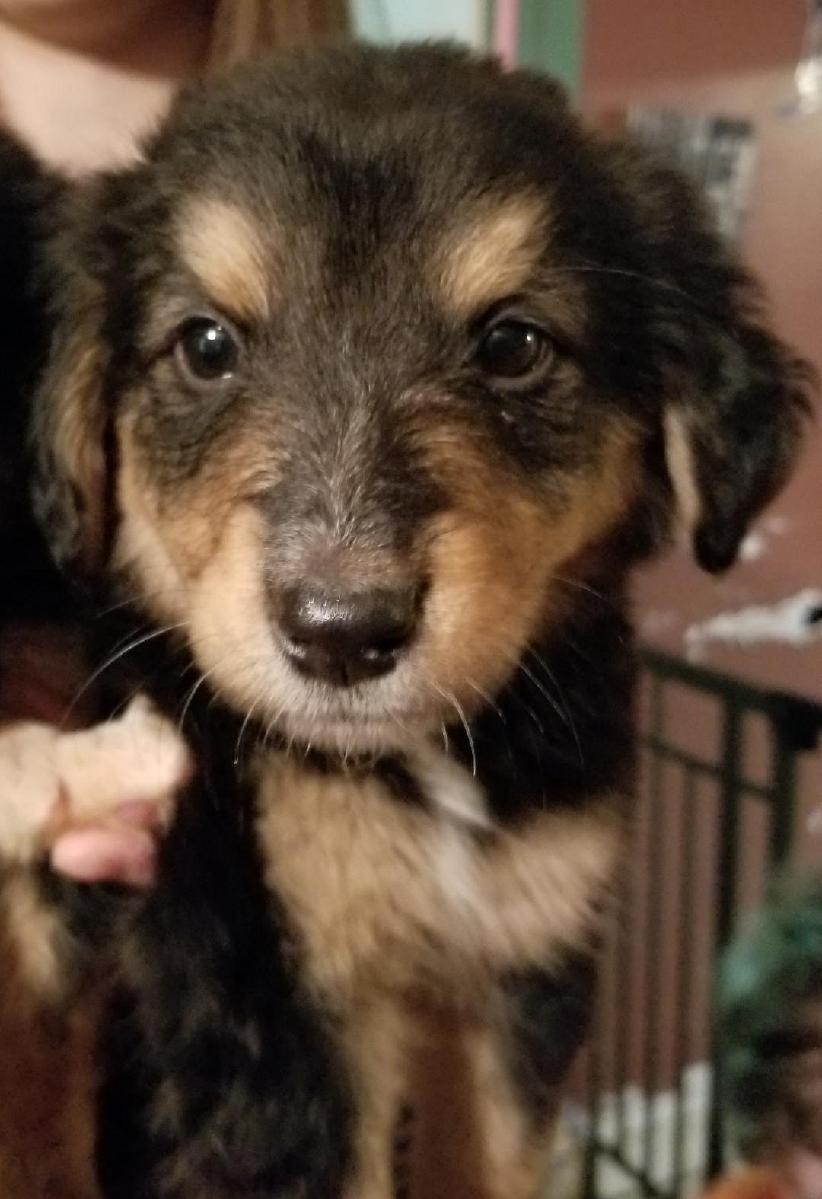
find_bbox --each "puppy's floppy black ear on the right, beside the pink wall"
[617,146,814,572]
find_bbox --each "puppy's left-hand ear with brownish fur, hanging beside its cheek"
[32,192,109,577]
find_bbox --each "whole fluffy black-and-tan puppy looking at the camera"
[9,47,806,1199]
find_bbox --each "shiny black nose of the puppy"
[279,583,418,687]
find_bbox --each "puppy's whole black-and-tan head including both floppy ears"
[30,48,803,747]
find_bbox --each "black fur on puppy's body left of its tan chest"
[99,733,356,1199]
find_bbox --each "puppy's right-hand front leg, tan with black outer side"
[411,958,593,1199]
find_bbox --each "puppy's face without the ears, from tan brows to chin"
[109,137,639,746]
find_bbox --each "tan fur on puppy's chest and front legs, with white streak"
[252,749,622,1199]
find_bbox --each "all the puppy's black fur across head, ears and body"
[6,48,806,1199]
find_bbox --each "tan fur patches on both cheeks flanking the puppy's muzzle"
[116,398,639,748]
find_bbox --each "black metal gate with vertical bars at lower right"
[576,651,822,1199]
